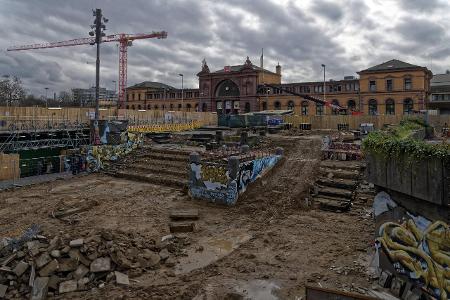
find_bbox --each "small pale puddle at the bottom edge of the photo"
[234,280,280,300]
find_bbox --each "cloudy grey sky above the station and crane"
[0,0,450,95]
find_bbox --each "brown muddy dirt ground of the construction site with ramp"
[0,135,374,300]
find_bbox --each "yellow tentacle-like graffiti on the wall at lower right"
[374,195,450,299]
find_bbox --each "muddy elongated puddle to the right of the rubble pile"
[175,231,251,274]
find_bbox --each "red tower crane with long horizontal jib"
[6,31,167,108]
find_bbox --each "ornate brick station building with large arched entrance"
[126,57,432,115]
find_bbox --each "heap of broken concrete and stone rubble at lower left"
[0,230,189,300]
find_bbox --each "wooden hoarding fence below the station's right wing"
[283,115,450,130]
